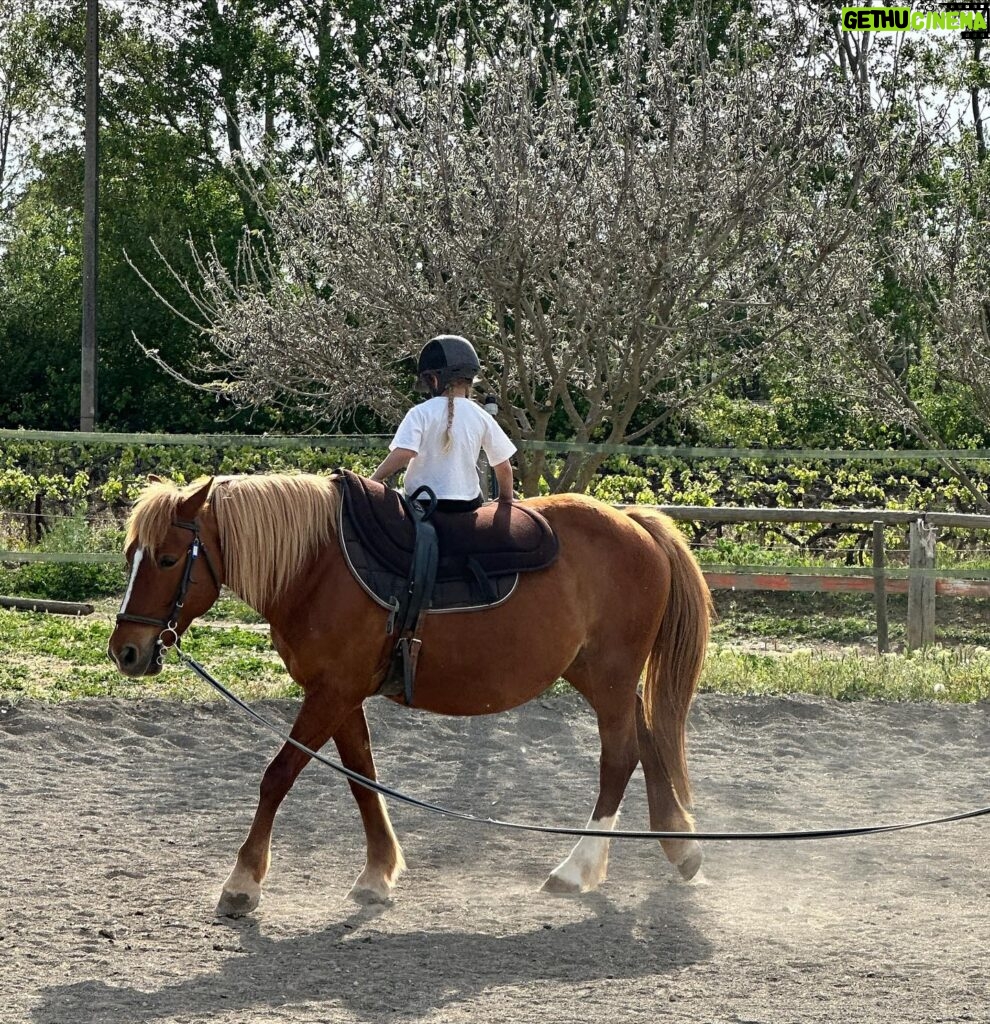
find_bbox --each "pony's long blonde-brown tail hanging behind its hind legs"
[627,509,713,809]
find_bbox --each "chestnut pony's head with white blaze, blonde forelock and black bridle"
[107,476,223,676]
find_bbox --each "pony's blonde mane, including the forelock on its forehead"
[126,473,340,613]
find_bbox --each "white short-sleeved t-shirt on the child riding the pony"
[389,395,516,502]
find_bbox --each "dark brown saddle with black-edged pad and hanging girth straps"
[339,469,558,705]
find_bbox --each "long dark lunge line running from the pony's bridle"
[159,643,990,842]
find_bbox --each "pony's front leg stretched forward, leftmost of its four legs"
[217,696,340,918]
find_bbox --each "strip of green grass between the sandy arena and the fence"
[0,599,990,702]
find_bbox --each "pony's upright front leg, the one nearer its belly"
[334,707,405,903]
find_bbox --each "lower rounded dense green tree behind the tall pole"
[0,120,255,431]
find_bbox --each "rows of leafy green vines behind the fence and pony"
[0,419,990,600]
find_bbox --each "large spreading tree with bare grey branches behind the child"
[145,2,888,493]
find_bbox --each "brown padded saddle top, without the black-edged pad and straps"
[340,469,558,580]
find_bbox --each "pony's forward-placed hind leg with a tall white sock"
[543,700,639,895]
